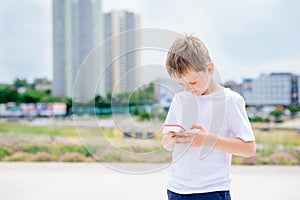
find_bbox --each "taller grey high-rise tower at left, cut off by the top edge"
[53,0,104,102]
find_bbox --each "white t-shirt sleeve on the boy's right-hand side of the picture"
[228,96,255,142]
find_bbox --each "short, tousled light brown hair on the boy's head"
[166,35,211,77]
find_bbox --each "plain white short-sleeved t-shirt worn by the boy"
[163,88,255,194]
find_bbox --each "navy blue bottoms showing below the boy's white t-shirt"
[167,190,231,200]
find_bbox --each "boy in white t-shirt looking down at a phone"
[162,36,256,200]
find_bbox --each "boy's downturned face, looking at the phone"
[175,64,213,96]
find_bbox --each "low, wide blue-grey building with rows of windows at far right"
[242,73,300,106]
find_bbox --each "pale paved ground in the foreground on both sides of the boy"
[0,163,300,200]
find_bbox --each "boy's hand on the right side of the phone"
[175,124,207,147]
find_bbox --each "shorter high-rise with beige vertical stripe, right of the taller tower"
[104,11,141,94]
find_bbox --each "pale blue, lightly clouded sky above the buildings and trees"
[0,0,300,83]
